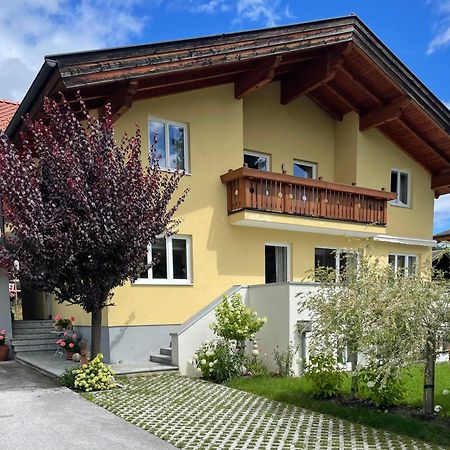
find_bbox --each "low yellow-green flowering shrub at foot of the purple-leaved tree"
[72,353,116,392]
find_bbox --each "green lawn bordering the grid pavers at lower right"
[228,363,450,448]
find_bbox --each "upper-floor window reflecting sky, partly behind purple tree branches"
[148,119,189,172]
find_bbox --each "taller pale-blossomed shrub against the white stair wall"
[211,294,267,341]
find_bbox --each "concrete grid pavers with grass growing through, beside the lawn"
[88,374,446,450]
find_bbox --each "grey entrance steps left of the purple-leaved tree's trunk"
[11,320,58,355]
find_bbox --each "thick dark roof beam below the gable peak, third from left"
[281,52,342,105]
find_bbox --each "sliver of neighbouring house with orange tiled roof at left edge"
[0,99,19,344]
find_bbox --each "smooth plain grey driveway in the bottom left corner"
[0,361,174,450]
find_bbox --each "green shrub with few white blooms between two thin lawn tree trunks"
[358,364,405,407]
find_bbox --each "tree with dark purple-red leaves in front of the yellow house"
[0,98,186,356]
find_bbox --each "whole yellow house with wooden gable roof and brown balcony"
[7,16,450,373]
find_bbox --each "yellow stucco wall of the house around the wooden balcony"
[54,83,433,326]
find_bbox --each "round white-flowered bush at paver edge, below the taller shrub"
[192,340,244,383]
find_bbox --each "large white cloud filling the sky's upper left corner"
[0,0,146,100]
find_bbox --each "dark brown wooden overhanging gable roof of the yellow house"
[6,16,450,196]
